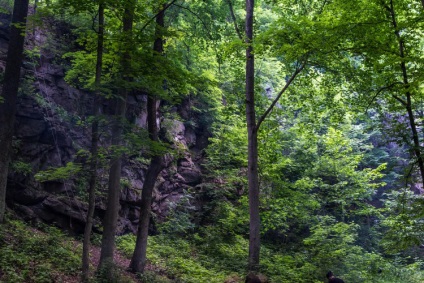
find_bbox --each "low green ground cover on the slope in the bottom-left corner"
[0,217,81,283]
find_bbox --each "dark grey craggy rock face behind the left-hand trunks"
[0,12,208,234]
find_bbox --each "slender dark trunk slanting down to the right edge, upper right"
[386,0,424,186]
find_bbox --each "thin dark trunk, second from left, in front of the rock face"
[81,1,104,282]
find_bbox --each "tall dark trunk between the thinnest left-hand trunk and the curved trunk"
[99,0,135,277]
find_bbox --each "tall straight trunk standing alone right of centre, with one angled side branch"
[245,0,260,272]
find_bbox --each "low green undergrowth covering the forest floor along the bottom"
[0,212,424,283]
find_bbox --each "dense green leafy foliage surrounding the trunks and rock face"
[0,0,424,283]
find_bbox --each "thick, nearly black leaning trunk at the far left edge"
[0,0,28,223]
